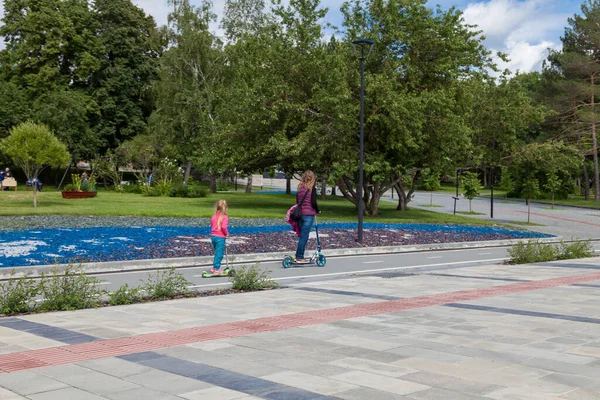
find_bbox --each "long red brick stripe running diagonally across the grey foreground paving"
[0,272,600,373]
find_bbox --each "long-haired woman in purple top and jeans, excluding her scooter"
[296,171,320,264]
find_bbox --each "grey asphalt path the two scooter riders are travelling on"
[65,242,600,291]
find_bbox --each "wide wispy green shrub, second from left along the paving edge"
[38,265,103,311]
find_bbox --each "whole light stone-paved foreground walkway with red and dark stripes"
[0,259,600,400]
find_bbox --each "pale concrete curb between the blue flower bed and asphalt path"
[0,237,580,280]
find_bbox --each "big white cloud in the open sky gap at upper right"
[464,0,568,72]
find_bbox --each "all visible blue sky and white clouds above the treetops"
[0,0,582,72]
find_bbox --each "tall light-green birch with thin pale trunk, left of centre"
[151,0,225,192]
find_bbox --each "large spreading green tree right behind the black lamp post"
[339,0,492,215]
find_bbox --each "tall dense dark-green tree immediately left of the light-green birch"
[91,0,164,148]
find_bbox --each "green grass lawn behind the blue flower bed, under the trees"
[0,188,491,225]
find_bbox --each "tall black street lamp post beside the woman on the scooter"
[352,39,375,244]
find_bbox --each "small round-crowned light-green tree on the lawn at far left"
[1,122,71,207]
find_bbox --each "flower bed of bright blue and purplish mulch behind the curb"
[0,217,548,267]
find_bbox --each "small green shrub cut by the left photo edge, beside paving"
[0,271,38,315]
